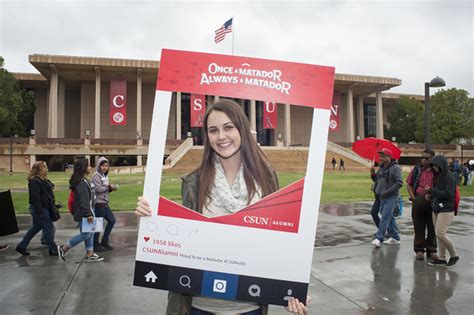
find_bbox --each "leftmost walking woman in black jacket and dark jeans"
[15,161,58,256]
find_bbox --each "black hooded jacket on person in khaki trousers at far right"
[430,155,456,213]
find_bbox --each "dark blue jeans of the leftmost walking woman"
[18,206,57,253]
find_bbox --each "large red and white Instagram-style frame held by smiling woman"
[134,49,335,305]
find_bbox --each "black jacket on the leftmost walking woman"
[28,177,54,216]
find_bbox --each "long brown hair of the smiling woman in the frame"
[196,99,278,210]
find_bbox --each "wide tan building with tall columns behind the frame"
[0,54,466,170]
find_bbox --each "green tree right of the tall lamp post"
[431,88,474,144]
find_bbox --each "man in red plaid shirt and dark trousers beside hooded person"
[406,149,438,260]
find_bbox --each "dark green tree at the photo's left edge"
[0,56,35,137]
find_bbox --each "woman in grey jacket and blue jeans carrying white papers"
[58,158,104,262]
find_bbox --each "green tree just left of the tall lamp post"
[384,96,424,143]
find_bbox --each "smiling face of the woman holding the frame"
[207,110,242,159]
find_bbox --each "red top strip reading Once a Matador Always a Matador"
[156,49,335,110]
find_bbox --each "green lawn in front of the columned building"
[0,171,474,213]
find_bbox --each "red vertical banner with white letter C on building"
[110,80,127,126]
